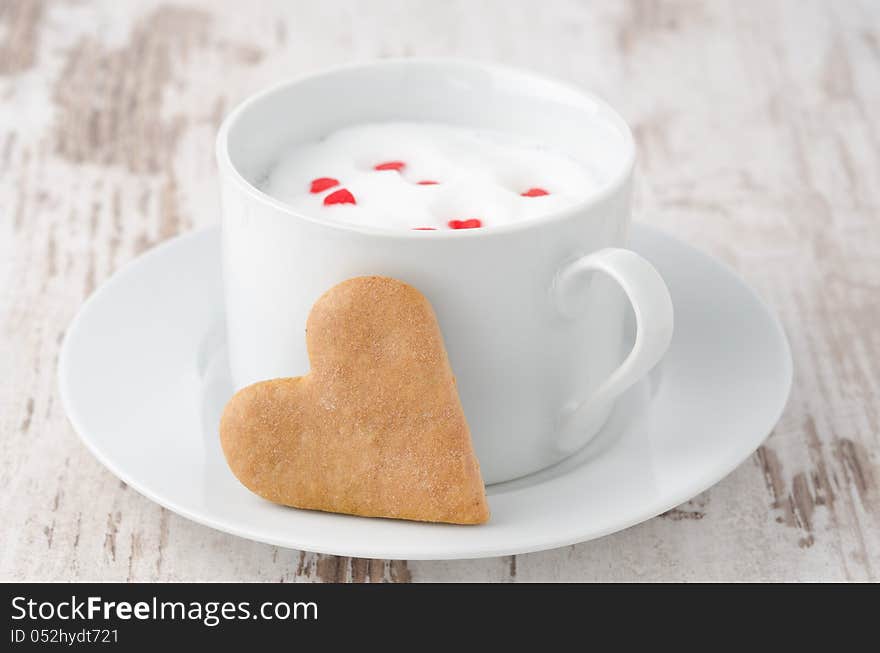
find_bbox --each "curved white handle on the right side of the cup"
[554,247,673,450]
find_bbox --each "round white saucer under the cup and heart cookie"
[59,225,792,559]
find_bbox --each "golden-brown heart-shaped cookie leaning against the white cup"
[220,277,489,524]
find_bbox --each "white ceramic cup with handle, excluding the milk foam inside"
[217,60,673,483]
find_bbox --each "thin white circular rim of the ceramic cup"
[215,57,636,240]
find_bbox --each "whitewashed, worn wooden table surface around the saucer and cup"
[0,0,880,581]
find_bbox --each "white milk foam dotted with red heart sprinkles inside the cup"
[260,122,601,229]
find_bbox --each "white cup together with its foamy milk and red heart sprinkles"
[217,59,673,482]
